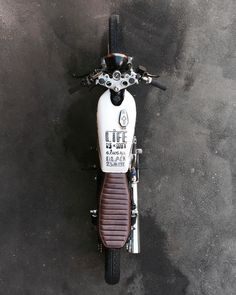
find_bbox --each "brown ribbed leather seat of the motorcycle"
[98,173,131,248]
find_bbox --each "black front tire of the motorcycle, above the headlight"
[109,14,122,53]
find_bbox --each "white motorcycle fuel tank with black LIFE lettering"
[97,90,136,173]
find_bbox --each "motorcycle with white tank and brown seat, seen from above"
[70,15,166,284]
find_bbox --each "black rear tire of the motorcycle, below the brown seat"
[105,248,120,285]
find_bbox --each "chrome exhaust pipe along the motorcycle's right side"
[126,136,142,254]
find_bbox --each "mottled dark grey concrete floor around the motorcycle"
[0,0,236,295]
